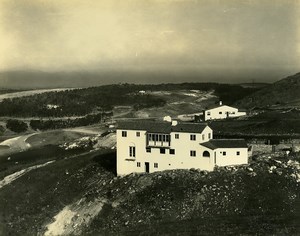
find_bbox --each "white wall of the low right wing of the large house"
[214,148,248,166]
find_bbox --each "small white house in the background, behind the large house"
[203,102,247,121]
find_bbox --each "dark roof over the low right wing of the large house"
[200,139,248,150]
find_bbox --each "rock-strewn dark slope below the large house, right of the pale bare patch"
[83,156,300,235]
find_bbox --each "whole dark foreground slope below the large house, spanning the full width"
[0,150,300,235]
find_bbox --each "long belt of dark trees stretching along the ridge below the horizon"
[0,83,258,117]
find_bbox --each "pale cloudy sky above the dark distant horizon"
[0,0,300,82]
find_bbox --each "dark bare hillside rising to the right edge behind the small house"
[236,73,300,108]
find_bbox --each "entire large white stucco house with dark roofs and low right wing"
[117,121,248,175]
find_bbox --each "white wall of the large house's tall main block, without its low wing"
[117,127,214,175]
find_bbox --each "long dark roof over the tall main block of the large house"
[117,120,208,133]
